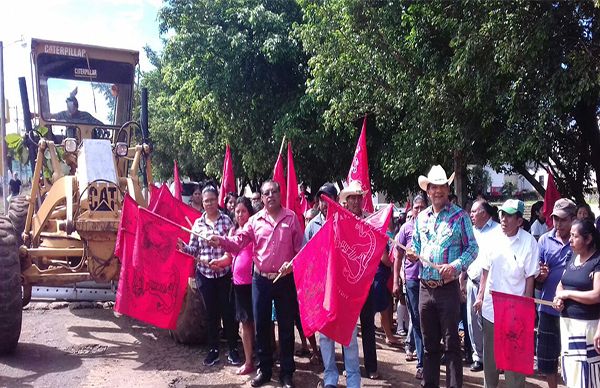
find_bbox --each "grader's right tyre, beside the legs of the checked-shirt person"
[170,282,207,345]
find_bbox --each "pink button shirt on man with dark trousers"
[219,208,304,273]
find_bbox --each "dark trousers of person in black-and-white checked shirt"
[196,272,238,350]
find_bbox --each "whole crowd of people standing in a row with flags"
[178,166,600,388]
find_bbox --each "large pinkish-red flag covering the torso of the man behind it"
[293,196,388,345]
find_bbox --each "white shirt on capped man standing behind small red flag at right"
[481,228,540,322]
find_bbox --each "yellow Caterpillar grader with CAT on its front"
[0,39,152,354]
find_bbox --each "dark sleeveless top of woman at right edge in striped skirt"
[560,251,600,320]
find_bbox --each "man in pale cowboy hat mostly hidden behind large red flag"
[340,181,379,379]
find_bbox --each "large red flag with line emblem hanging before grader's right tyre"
[115,208,194,330]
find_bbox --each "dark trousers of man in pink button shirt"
[252,274,298,377]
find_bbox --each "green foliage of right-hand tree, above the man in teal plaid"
[299,0,600,197]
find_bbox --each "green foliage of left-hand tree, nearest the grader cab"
[144,0,346,189]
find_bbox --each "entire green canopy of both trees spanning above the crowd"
[144,0,600,199]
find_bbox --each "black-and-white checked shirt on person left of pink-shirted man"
[183,211,233,278]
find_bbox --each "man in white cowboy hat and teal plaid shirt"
[406,165,479,388]
